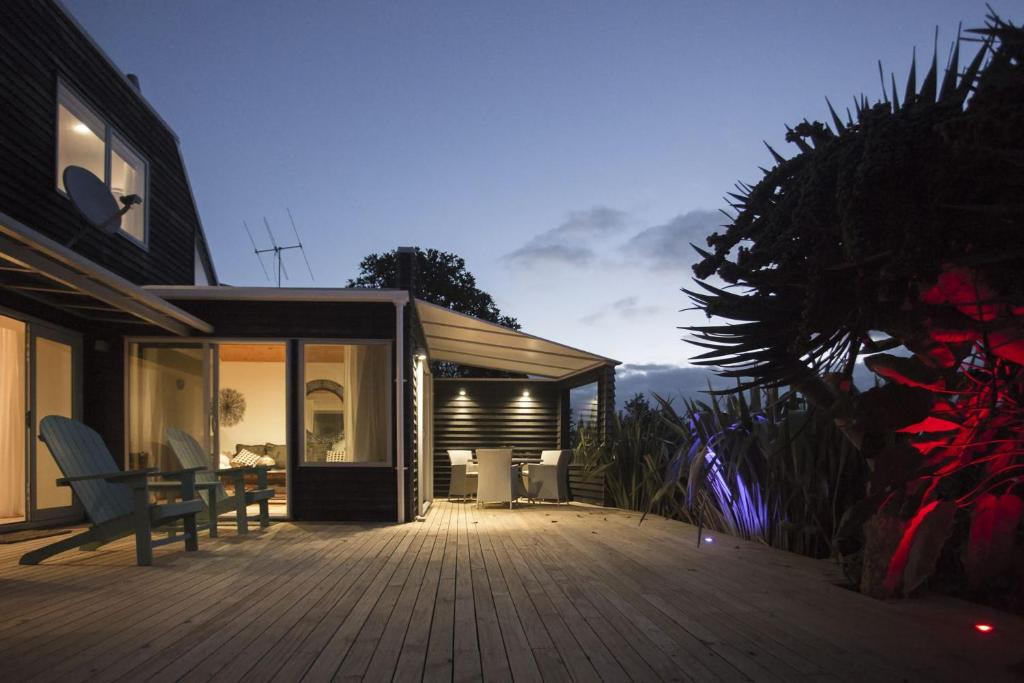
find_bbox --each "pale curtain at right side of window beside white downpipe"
[345,344,390,463]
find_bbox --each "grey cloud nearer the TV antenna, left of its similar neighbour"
[504,206,628,266]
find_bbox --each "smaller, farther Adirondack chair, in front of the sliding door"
[167,427,273,539]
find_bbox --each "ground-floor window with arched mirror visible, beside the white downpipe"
[302,343,391,465]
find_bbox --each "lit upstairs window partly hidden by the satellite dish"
[56,84,148,245]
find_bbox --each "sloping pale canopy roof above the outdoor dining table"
[416,299,618,379]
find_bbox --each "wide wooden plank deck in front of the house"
[0,503,1024,683]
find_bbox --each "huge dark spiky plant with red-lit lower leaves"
[687,15,1024,595]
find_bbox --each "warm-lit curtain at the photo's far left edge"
[0,318,26,517]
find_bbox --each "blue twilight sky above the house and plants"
[65,0,991,393]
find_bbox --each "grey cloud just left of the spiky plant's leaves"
[623,209,725,270]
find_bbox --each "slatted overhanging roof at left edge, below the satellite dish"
[0,213,213,336]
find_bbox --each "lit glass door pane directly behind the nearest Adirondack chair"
[32,328,78,517]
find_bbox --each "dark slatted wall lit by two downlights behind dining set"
[434,378,560,498]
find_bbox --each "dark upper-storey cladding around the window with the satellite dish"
[0,0,199,285]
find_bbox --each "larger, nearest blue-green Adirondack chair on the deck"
[20,415,203,565]
